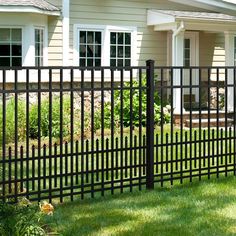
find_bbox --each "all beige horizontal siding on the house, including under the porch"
[45,0,228,69]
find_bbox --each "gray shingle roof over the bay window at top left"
[0,0,59,11]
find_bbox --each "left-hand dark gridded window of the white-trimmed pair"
[79,30,102,66]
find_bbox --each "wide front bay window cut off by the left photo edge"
[0,28,22,66]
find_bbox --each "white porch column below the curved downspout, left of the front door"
[172,24,184,114]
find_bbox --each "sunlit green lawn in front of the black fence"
[45,177,236,236]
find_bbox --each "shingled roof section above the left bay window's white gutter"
[0,0,60,13]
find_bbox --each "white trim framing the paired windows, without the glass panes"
[73,24,138,66]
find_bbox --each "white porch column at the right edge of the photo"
[225,32,236,112]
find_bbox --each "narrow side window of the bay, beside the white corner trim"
[34,29,44,66]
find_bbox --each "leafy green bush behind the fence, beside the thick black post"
[95,75,170,129]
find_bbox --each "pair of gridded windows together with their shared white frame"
[75,25,137,67]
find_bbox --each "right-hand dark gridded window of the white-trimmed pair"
[110,32,131,66]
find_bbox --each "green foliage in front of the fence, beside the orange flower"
[0,199,46,236]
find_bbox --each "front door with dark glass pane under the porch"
[183,32,199,108]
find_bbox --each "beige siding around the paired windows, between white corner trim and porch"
[70,0,206,65]
